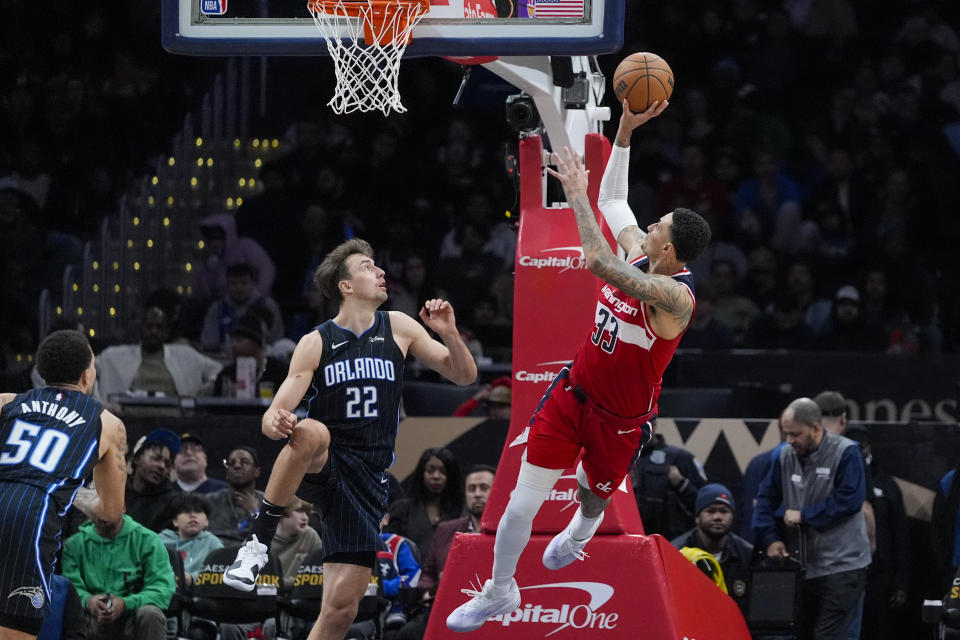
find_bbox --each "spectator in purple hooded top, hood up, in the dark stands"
[193,213,277,301]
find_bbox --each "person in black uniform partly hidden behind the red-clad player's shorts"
[630,434,707,540]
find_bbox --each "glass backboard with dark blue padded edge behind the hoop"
[162,0,624,57]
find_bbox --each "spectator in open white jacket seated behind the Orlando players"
[96,307,222,404]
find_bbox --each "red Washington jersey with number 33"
[570,256,696,418]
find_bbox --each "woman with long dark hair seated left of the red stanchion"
[386,447,463,554]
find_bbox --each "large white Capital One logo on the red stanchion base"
[490,582,620,638]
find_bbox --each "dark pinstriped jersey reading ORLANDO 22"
[307,311,404,471]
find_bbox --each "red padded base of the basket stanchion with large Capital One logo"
[424,533,750,640]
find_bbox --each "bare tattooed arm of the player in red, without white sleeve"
[547,149,693,340]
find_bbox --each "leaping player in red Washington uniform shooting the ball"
[447,102,710,631]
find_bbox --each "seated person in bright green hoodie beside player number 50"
[63,515,175,640]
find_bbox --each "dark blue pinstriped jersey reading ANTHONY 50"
[0,387,103,502]
